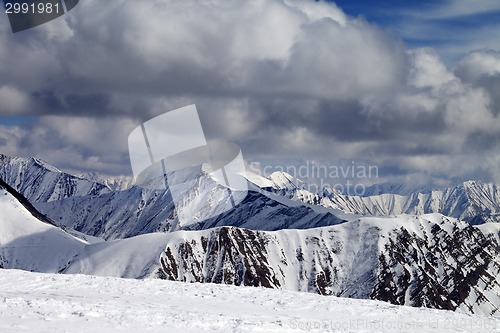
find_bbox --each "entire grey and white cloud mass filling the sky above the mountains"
[0,0,500,184]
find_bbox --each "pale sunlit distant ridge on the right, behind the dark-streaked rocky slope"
[249,172,500,224]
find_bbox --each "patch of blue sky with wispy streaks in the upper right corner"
[335,0,500,63]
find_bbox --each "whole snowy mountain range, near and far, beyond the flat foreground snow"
[0,156,500,315]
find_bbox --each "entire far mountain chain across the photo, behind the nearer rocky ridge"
[0,156,500,243]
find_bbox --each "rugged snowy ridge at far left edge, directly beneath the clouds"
[0,154,110,203]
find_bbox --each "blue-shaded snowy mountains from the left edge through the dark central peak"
[0,155,343,239]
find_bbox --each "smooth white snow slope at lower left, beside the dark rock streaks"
[0,183,168,278]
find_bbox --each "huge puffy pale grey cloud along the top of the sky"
[0,0,404,114]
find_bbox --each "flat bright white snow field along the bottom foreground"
[0,269,500,333]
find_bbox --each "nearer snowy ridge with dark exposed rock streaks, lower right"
[161,214,500,315]
